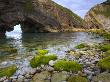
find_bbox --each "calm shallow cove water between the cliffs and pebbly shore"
[0,31,103,61]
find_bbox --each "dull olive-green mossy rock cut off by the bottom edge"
[67,75,89,82]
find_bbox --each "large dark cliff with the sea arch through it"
[0,0,83,33]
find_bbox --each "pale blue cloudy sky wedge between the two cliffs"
[53,0,106,18]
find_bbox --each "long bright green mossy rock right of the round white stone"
[54,60,82,72]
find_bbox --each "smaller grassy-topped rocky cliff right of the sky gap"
[85,0,110,31]
